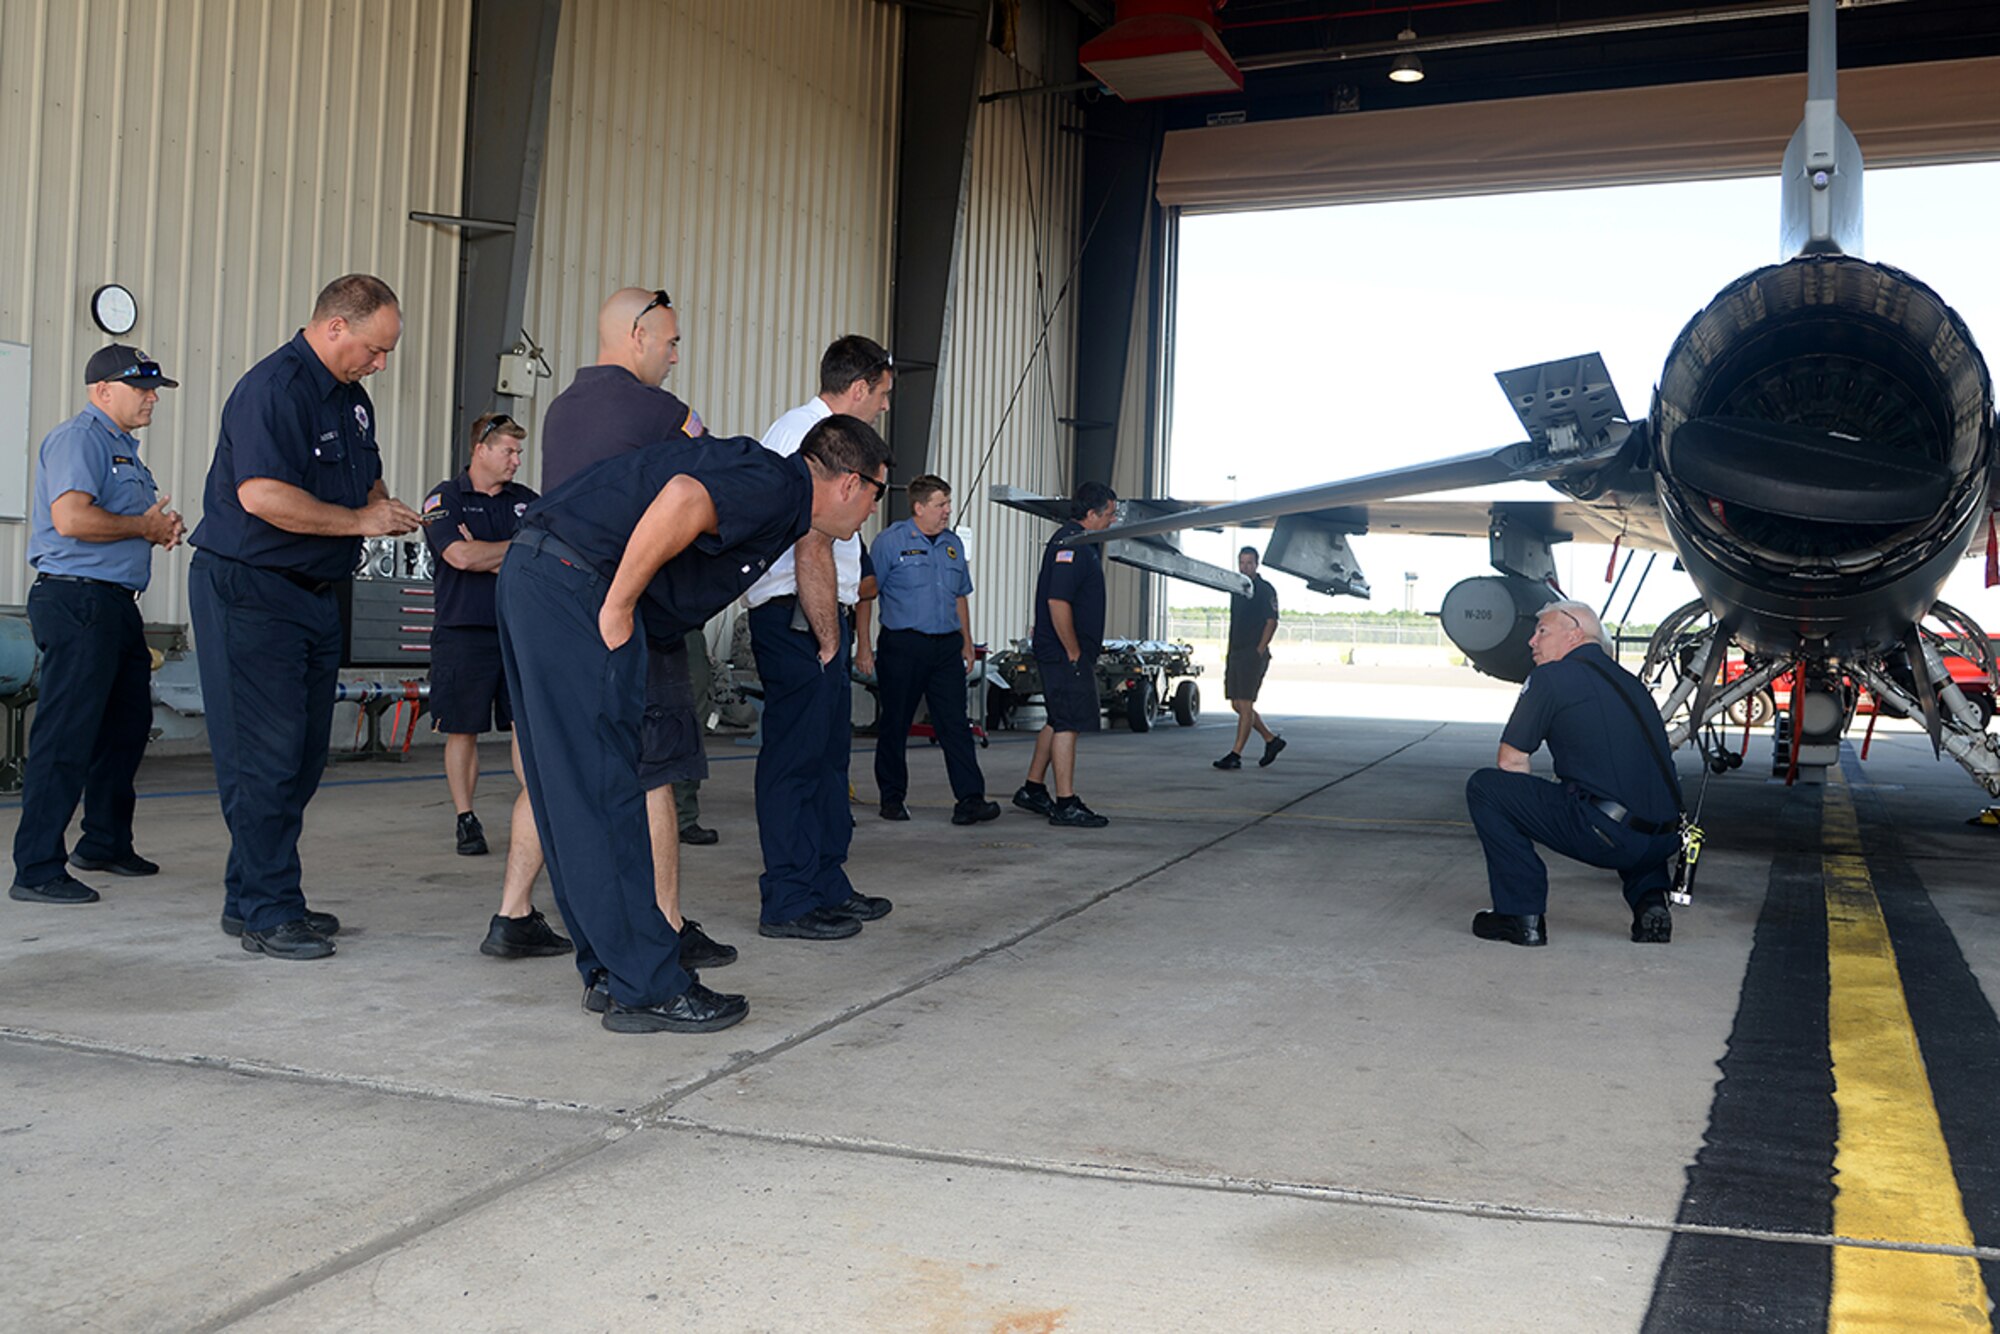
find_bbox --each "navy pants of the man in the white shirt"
[750,598,854,922]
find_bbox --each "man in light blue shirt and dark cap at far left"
[8,344,182,904]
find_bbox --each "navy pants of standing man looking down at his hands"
[188,552,342,932]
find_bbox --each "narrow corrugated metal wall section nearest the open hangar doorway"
[932,52,1088,648]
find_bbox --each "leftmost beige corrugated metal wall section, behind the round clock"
[0,0,470,620]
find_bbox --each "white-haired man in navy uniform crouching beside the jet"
[1466,602,1680,944]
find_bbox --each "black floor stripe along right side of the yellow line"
[1848,760,2000,1292]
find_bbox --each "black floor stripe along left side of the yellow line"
[1644,788,1838,1334]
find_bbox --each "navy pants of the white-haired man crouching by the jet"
[1466,768,1678,916]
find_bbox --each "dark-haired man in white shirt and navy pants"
[746,334,896,940]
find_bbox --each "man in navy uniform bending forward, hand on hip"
[498,416,888,1032]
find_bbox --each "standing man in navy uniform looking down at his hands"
[188,274,418,960]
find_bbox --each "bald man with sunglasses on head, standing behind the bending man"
[532,288,736,968]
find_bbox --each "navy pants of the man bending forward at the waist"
[496,538,690,1006]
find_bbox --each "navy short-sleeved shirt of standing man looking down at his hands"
[188,330,382,580]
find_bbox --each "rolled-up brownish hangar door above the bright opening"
[1160,58,2000,210]
